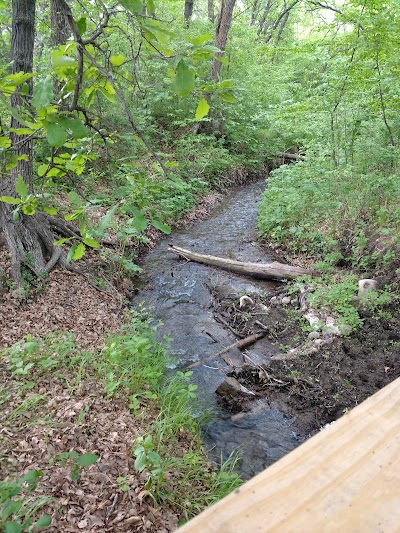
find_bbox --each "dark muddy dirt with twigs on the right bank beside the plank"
[209,276,400,440]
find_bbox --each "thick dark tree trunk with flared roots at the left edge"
[0,0,63,288]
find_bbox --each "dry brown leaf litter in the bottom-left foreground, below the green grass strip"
[0,368,178,533]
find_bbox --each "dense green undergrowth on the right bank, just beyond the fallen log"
[258,158,400,272]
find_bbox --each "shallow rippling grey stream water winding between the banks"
[132,182,299,479]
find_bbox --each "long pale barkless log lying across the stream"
[169,245,313,279]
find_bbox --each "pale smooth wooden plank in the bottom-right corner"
[179,378,400,533]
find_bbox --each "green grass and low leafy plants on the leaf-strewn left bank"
[0,312,240,532]
